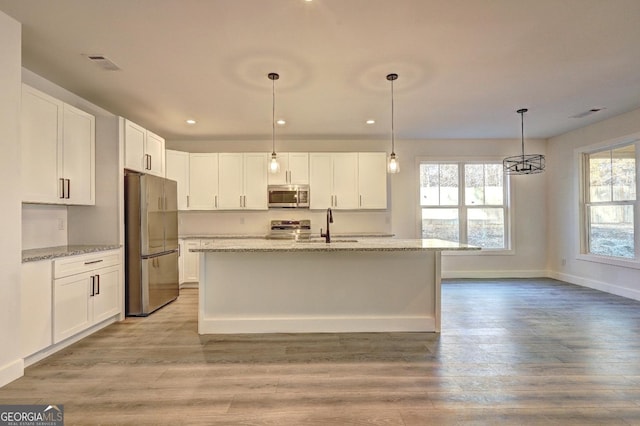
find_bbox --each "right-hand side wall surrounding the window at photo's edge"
[547,109,640,300]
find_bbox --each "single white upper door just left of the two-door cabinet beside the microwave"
[188,153,218,210]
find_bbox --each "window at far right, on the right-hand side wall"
[583,143,637,259]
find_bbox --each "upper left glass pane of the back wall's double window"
[420,164,458,206]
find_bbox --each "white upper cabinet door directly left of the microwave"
[243,152,268,210]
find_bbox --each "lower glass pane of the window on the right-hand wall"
[589,206,635,258]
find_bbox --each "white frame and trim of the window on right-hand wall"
[575,133,640,269]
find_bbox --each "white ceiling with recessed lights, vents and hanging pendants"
[0,0,640,140]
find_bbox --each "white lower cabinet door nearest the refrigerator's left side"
[89,266,122,324]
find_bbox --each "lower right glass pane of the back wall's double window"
[467,208,505,249]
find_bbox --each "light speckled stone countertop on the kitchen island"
[190,237,480,253]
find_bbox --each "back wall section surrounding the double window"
[391,139,547,277]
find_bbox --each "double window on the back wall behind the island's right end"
[420,162,509,250]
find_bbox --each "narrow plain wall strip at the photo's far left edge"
[0,12,24,386]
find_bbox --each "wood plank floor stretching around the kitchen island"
[0,279,640,425]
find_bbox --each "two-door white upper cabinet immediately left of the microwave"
[218,152,268,210]
